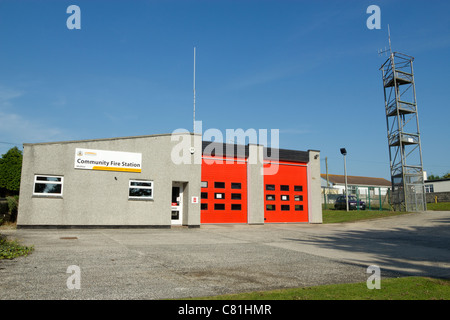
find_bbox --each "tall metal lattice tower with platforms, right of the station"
[380,50,426,211]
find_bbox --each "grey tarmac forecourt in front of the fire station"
[0,211,450,300]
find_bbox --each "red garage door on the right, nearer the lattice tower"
[264,161,308,223]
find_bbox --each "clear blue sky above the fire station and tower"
[0,0,450,179]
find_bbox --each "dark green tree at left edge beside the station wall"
[0,147,23,195]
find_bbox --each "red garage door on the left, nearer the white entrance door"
[200,157,247,223]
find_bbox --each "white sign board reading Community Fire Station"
[75,148,142,172]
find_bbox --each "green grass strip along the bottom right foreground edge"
[194,277,450,300]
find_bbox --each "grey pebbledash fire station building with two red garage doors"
[17,133,322,228]
